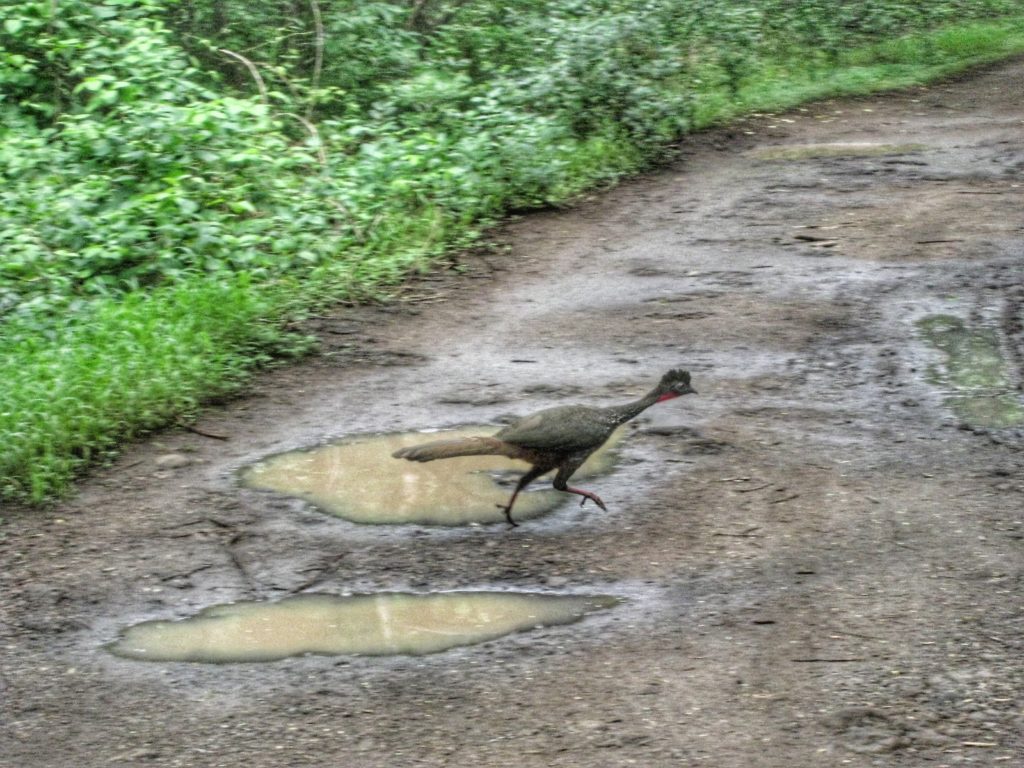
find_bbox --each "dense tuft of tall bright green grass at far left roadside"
[0,280,295,501]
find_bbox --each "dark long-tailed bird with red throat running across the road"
[392,369,696,527]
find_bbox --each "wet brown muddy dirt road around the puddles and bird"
[6,61,1024,768]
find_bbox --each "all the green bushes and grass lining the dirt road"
[0,0,1024,502]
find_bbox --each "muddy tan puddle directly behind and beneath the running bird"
[242,426,625,525]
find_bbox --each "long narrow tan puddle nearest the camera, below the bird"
[108,592,621,664]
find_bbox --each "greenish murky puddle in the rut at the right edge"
[918,314,1024,428]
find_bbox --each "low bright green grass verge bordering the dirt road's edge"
[6,17,1024,503]
